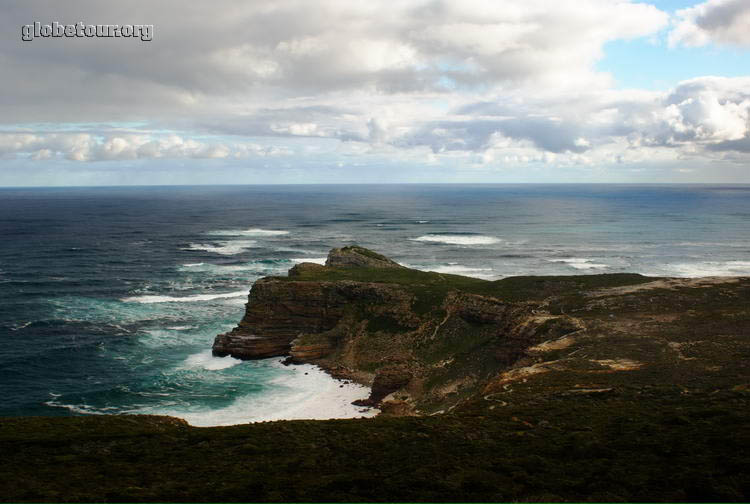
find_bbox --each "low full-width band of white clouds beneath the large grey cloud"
[0,77,750,163]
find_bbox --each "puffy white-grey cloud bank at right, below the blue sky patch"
[393,77,750,157]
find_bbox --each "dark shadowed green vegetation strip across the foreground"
[0,389,750,502]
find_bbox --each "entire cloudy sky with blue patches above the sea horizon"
[0,0,750,186]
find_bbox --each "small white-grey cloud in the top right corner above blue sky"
[669,0,750,47]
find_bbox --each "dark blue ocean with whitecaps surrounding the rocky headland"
[0,185,750,424]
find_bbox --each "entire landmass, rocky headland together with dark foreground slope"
[0,246,750,502]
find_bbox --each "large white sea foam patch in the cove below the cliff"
[155,359,378,427]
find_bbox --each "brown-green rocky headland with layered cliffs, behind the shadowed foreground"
[213,247,750,415]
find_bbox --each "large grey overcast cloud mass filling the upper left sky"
[0,0,667,126]
